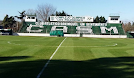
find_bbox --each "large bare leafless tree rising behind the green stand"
[36,4,56,22]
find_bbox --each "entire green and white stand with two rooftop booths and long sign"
[18,15,127,38]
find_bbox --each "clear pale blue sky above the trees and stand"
[0,0,134,22]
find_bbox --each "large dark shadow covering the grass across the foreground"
[0,57,134,78]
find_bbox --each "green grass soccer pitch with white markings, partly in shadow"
[0,36,134,78]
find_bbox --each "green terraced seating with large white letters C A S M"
[20,22,125,35]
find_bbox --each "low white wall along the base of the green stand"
[13,33,127,38]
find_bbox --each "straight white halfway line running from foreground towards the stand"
[37,37,67,78]
